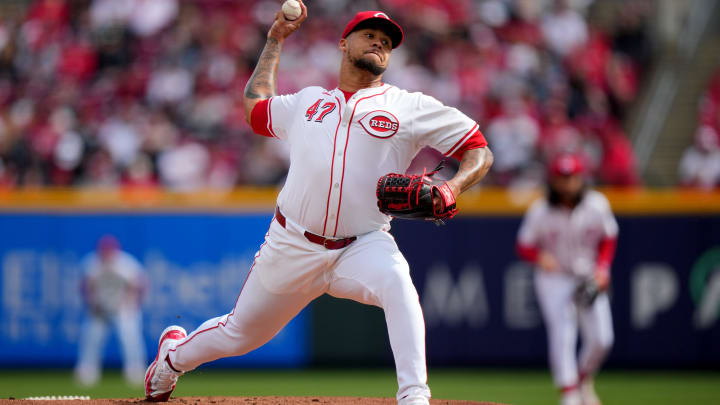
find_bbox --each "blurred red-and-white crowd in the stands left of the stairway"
[0,0,648,190]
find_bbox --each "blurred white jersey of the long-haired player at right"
[518,190,618,276]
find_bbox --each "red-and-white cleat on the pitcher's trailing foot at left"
[145,325,187,402]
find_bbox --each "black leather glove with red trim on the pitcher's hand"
[375,167,457,225]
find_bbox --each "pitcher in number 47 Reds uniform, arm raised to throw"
[146,1,492,404]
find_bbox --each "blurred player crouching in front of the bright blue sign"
[75,235,147,385]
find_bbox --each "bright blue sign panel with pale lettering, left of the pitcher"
[0,214,309,366]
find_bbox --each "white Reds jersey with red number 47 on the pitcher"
[252,84,479,238]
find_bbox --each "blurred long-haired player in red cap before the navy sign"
[518,155,618,405]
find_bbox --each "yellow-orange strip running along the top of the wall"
[0,187,720,215]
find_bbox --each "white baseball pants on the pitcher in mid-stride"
[169,211,430,399]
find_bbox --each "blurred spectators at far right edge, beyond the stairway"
[680,68,720,190]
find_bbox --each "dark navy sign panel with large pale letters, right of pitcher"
[392,216,720,367]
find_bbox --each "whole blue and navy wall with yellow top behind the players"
[0,189,720,367]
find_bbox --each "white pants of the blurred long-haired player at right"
[535,270,613,388]
